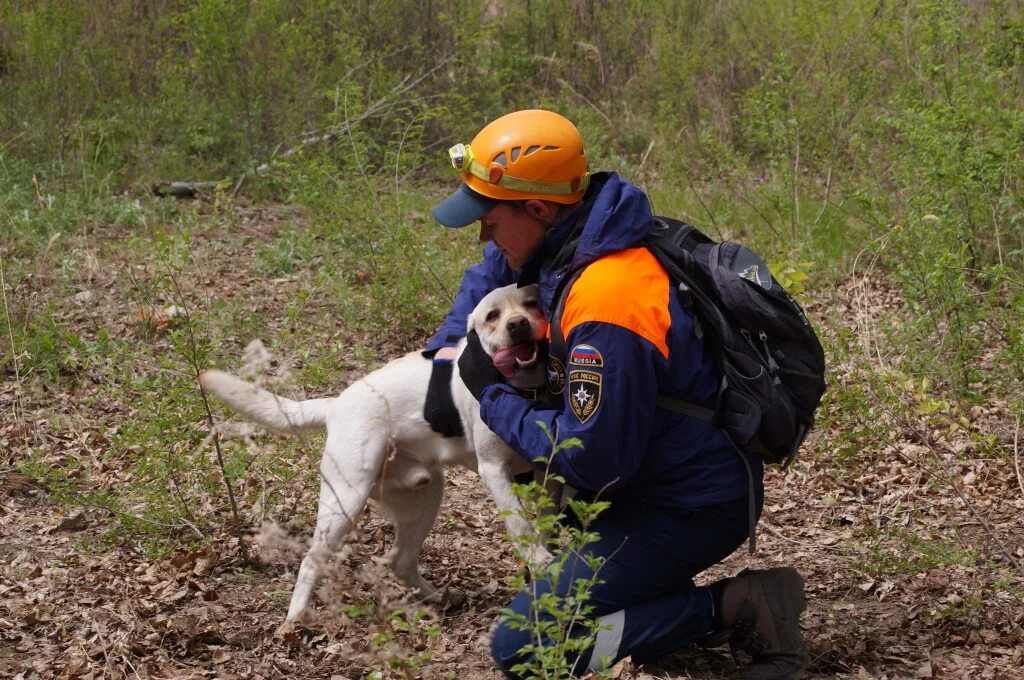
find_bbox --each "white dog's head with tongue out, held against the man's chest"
[467,284,548,388]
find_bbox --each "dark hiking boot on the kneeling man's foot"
[721,566,807,680]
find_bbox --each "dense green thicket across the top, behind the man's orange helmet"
[0,0,1024,266]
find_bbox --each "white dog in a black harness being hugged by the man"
[200,286,550,621]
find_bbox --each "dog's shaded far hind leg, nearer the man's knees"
[380,468,444,602]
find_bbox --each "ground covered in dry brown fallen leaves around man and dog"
[0,199,1024,680]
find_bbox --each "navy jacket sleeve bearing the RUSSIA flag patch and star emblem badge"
[480,322,666,492]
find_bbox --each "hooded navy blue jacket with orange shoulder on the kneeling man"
[427,173,763,508]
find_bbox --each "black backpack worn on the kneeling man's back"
[551,217,825,466]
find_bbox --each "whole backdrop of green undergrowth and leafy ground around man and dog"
[0,0,1024,678]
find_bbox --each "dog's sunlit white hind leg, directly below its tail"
[286,427,388,621]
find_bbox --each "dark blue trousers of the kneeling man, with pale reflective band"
[490,493,763,678]
